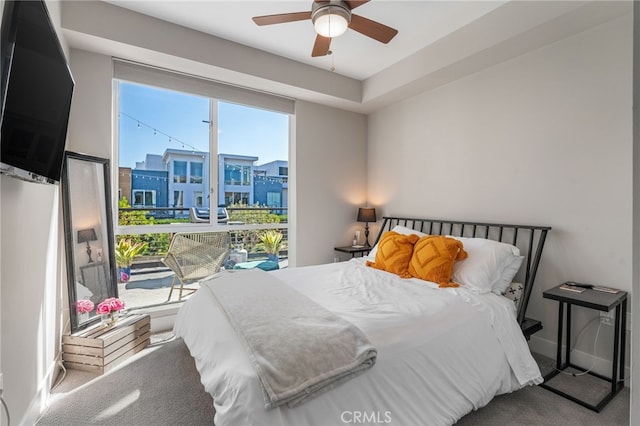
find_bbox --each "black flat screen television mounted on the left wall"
[0,0,74,183]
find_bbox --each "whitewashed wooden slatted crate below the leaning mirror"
[62,314,151,374]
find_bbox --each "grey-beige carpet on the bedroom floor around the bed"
[38,335,629,426]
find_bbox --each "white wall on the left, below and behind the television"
[0,1,67,424]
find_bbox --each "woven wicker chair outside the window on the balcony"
[162,231,231,301]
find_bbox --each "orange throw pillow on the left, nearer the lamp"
[367,231,420,278]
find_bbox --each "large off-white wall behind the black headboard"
[367,14,632,370]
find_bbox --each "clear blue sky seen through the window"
[119,82,289,168]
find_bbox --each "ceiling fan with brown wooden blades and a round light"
[253,0,398,57]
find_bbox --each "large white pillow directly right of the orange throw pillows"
[451,237,524,295]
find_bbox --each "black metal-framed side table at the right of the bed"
[540,286,627,413]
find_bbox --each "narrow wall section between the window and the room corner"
[289,101,367,266]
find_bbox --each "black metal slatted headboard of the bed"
[375,216,551,325]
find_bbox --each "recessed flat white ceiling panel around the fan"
[108,0,506,80]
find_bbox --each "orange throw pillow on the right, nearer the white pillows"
[409,235,467,287]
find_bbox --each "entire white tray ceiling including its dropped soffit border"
[62,0,632,113]
